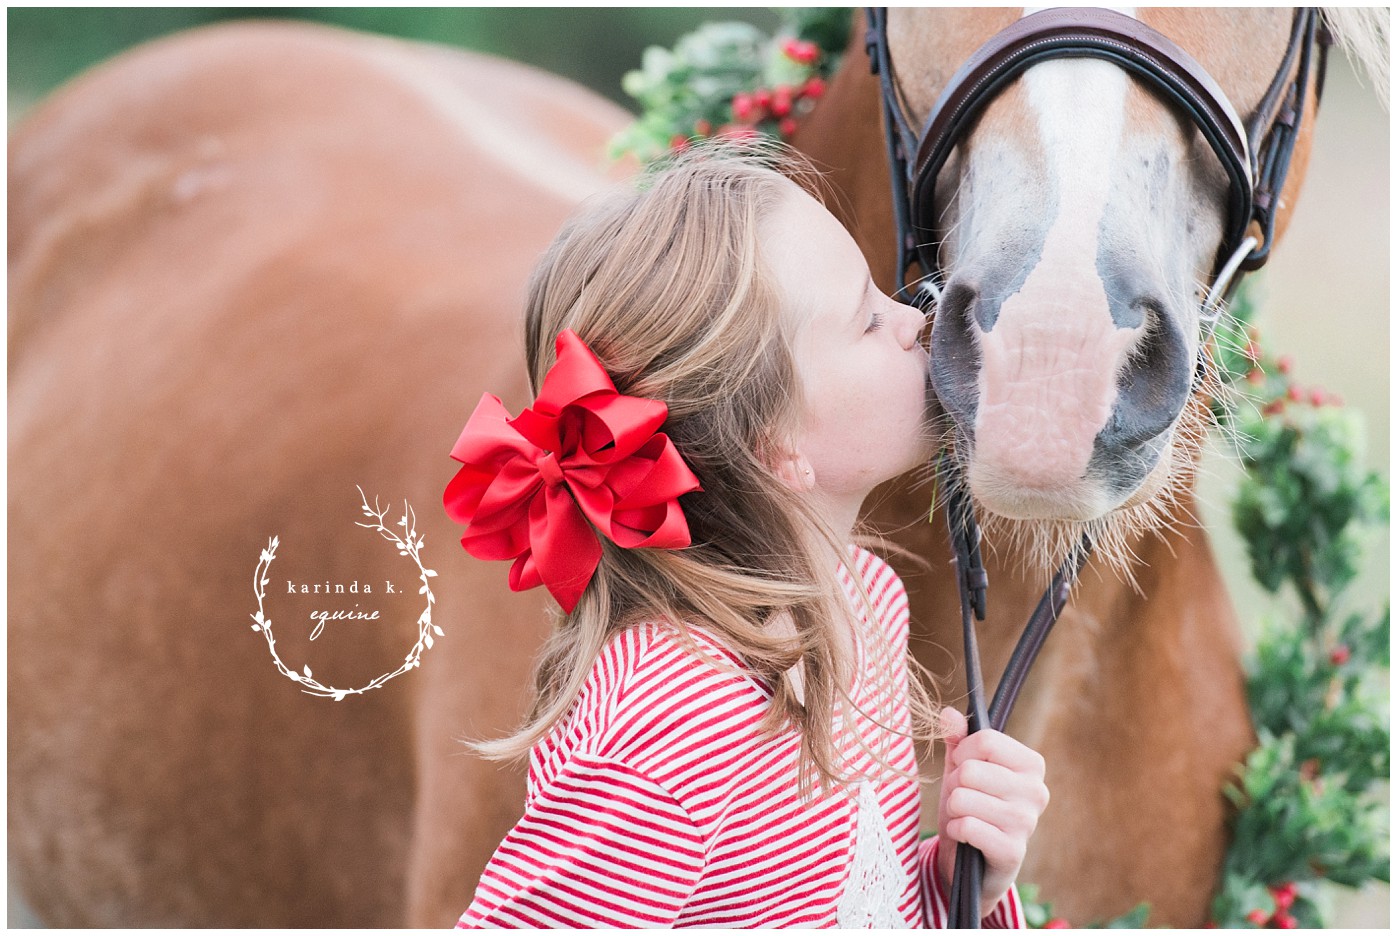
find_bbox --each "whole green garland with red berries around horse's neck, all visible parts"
[612,8,1390,929]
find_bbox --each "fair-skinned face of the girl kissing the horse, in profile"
[761,183,932,525]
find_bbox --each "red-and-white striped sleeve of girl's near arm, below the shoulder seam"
[457,757,704,929]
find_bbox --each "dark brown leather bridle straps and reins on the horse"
[865,7,1333,929]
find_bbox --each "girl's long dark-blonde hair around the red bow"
[472,144,935,791]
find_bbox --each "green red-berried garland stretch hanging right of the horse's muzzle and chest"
[1213,292,1391,929]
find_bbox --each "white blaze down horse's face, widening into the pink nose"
[971,40,1137,515]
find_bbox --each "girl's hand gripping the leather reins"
[936,707,1048,914]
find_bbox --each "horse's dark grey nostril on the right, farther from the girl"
[1098,298,1193,450]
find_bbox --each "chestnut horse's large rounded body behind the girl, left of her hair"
[8,25,627,926]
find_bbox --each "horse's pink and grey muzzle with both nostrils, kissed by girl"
[932,271,1196,521]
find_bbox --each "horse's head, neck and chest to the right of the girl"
[796,8,1363,926]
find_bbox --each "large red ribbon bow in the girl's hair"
[443,330,701,612]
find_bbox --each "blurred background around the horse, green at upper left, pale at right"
[7,7,1391,926]
